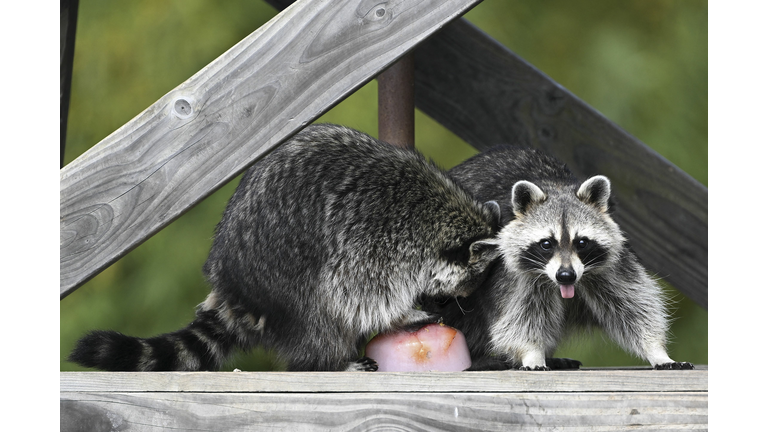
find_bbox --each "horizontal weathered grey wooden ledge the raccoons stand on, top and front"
[60,366,708,431]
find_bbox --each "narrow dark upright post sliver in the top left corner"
[59,0,80,167]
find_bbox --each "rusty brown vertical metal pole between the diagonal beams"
[377,53,416,149]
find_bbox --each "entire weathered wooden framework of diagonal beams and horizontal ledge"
[59,0,707,430]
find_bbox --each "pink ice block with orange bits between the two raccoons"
[365,324,472,372]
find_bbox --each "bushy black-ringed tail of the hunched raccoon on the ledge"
[69,310,238,371]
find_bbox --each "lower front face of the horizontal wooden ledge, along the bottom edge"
[60,392,708,431]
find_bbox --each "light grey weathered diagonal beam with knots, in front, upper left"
[59,0,480,298]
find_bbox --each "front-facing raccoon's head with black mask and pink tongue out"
[499,176,624,298]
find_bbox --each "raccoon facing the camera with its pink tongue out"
[425,146,693,370]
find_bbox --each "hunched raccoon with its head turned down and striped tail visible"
[69,125,499,371]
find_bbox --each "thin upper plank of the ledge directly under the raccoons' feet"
[60,366,708,393]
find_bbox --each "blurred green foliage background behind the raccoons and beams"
[60,0,708,370]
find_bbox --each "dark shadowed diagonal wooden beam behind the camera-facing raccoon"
[415,19,708,309]
